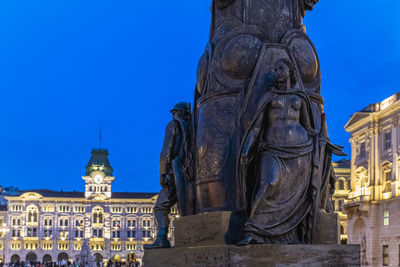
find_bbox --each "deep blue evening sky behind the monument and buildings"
[0,0,400,192]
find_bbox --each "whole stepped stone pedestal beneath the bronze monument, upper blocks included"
[143,212,360,267]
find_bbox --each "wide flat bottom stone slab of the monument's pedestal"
[143,245,360,267]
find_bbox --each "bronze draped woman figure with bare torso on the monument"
[239,59,317,245]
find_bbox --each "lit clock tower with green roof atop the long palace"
[82,149,115,200]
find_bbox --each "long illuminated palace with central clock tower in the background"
[0,149,177,264]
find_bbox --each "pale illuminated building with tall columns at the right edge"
[345,93,400,266]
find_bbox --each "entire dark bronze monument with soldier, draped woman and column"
[145,0,343,249]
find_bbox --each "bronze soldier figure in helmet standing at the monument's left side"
[144,102,193,249]
